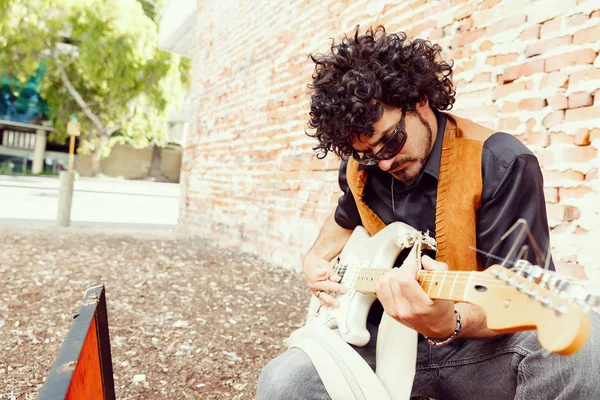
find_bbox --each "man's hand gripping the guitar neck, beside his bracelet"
[375,256,456,338]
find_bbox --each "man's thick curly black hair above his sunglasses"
[307,26,456,158]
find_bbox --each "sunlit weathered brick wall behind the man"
[180,0,600,283]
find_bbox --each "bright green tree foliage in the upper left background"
[0,0,190,172]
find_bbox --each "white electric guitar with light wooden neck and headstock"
[308,222,600,355]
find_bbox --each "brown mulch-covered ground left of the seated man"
[0,226,309,399]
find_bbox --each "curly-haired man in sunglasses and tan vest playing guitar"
[258,27,600,400]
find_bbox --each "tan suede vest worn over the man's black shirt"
[346,113,494,271]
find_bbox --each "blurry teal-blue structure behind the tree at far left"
[0,61,48,125]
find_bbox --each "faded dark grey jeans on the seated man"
[257,312,600,400]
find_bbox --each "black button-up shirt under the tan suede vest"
[335,112,554,270]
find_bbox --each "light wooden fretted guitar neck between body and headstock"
[354,268,474,301]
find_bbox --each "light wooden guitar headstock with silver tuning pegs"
[465,261,600,355]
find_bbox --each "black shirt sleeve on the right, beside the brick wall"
[477,134,554,270]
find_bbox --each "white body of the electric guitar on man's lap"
[307,222,417,346]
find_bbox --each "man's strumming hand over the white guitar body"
[302,252,348,307]
